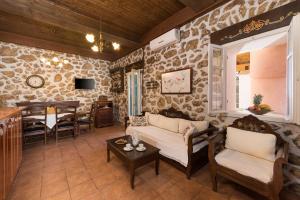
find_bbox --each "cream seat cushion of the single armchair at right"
[215,149,274,183]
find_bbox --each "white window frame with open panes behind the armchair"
[208,14,300,125]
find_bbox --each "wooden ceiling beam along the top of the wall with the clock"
[0,31,115,61]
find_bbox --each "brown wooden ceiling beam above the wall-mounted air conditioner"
[141,0,230,45]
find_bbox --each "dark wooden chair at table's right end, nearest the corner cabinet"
[77,103,95,134]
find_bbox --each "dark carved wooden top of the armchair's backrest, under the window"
[229,115,284,147]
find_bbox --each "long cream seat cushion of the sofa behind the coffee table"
[126,126,208,167]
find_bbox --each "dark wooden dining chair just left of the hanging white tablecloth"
[22,105,48,144]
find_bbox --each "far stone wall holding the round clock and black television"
[0,42,111,110]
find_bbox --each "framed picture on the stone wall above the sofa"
[161,68,193,94]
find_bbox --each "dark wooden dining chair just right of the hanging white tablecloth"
[55,104,77,142]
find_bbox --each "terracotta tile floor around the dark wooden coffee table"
[9,126,263,200]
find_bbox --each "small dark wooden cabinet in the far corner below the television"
[95,101,114,128]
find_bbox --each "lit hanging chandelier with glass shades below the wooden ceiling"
[85,19,120,53]
